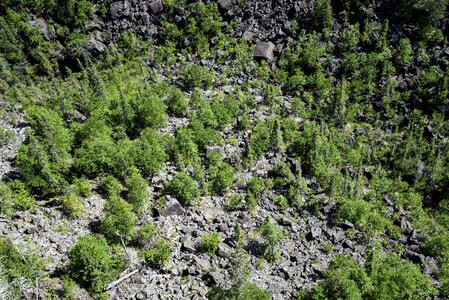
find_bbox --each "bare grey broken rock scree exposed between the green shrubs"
[0,0,449,300]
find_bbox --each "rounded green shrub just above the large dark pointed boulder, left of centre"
[165,172,200,206]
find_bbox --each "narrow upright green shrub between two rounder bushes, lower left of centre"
[125,167,150,213]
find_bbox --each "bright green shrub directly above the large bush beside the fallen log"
[101,195,137,242]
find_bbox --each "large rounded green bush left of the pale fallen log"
[68,236,123,297]
